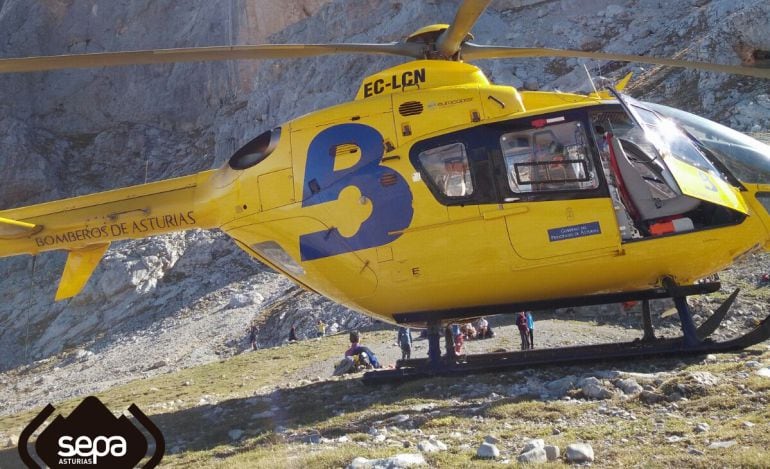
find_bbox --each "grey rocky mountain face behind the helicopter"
[0,0,770,370]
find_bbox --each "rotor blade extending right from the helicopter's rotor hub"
[462,43,770,78]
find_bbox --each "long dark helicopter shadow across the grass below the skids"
[0,350,762,468]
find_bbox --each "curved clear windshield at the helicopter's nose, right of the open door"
[644,103,770,184]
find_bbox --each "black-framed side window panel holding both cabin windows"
[409,111,608,206]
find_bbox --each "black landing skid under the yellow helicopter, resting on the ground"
[363,290,770,384]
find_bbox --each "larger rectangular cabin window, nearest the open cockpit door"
[500,121,599,194]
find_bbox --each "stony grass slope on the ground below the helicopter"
[0,331,770,468]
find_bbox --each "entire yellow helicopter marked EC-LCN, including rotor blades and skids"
[0,0,770,379]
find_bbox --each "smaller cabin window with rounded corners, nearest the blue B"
[418,143,473,199]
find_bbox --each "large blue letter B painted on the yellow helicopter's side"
[299,124,414,261]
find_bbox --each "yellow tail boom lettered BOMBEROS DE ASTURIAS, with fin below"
[0,171,211,300]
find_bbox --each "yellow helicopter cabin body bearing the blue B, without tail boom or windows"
[204,62,768,322]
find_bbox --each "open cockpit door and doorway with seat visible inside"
[591,94,747,241]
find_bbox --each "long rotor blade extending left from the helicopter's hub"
[0,42,424,73]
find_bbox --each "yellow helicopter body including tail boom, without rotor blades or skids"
[0,61,770,322]
